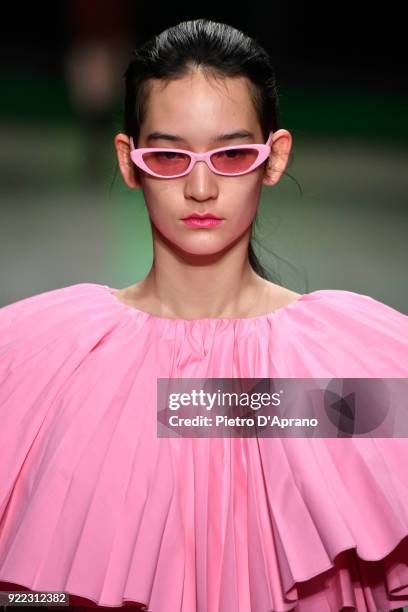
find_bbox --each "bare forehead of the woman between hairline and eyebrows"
[141,71,258,133]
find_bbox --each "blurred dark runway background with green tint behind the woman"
[0,0,408,312]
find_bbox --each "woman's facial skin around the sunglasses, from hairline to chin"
[137,72,264,255]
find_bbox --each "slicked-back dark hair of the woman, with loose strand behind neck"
[119,18,298,282]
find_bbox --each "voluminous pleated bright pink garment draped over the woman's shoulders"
[0,283,408,612]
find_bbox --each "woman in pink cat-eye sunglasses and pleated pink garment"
[0,19,408,612]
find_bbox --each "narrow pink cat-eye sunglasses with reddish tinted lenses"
[130,132,273,178]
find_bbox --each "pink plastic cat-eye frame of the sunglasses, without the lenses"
[130,131,273,179]
